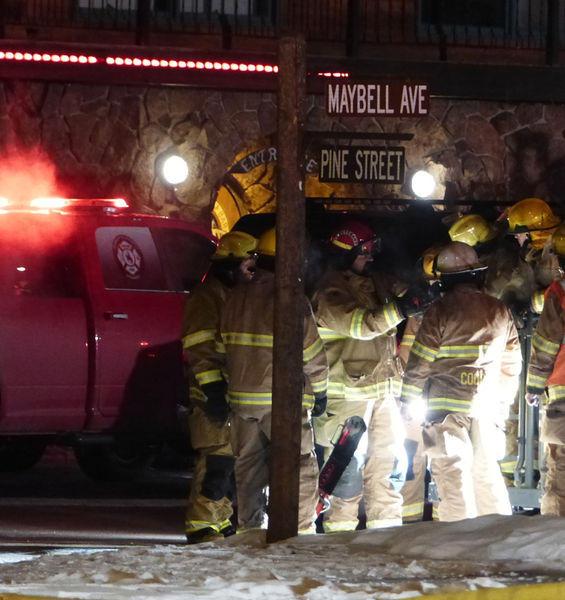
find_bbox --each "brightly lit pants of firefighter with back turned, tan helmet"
[423,414,512,521]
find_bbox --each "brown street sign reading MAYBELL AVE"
[326,81,430,117]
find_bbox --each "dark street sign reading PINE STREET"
[319,146,404,184]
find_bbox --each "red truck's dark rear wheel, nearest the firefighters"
[74,440,154,482]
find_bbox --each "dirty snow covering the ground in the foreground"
[0,515,565,600]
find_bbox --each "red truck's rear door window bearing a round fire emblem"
[96,227,167,291]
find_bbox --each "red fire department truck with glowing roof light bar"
[0,198,215,480]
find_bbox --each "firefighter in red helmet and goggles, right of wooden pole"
[313,221,430,532]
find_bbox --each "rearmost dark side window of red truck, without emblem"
[152,228,214,292]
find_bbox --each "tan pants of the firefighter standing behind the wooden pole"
[231,410,318,531]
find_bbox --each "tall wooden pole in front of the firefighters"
[267,36,306,542]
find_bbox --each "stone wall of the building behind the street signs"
[0,81,565,230]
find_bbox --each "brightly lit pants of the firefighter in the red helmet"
[315,396,406,532]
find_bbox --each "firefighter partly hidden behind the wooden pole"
[221,229,328,533]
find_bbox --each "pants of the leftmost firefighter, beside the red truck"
[185,403,234,532]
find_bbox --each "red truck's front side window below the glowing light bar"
[0,247,80,298]
